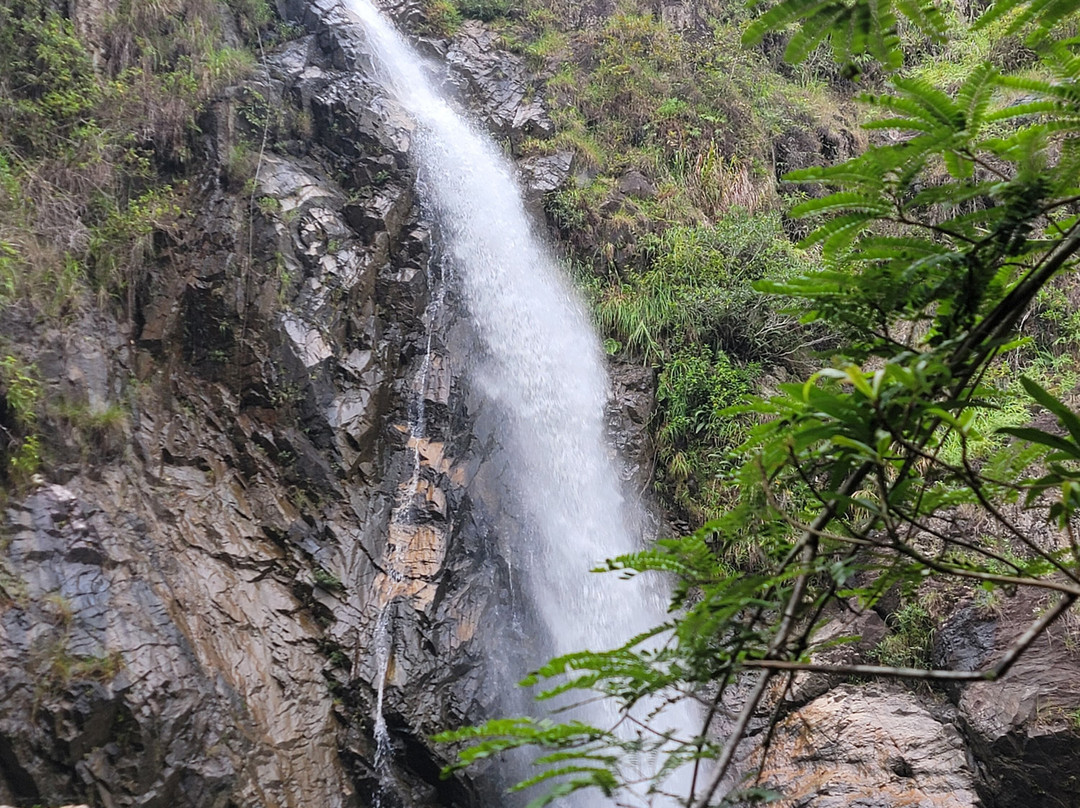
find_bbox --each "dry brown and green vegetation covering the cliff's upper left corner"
[0,0,273,318]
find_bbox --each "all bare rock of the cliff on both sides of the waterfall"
[0,0,1080,808]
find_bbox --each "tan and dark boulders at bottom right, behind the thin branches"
[738,594,1080,808]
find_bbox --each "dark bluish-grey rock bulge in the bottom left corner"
[0,485,254,806]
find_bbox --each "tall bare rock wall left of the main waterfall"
[0,2,574,806]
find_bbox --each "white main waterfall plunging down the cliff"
[347,0,699,803]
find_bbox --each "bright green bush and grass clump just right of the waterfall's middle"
[593,207,813,526]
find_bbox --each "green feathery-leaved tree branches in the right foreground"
[434,0,1080,808]
